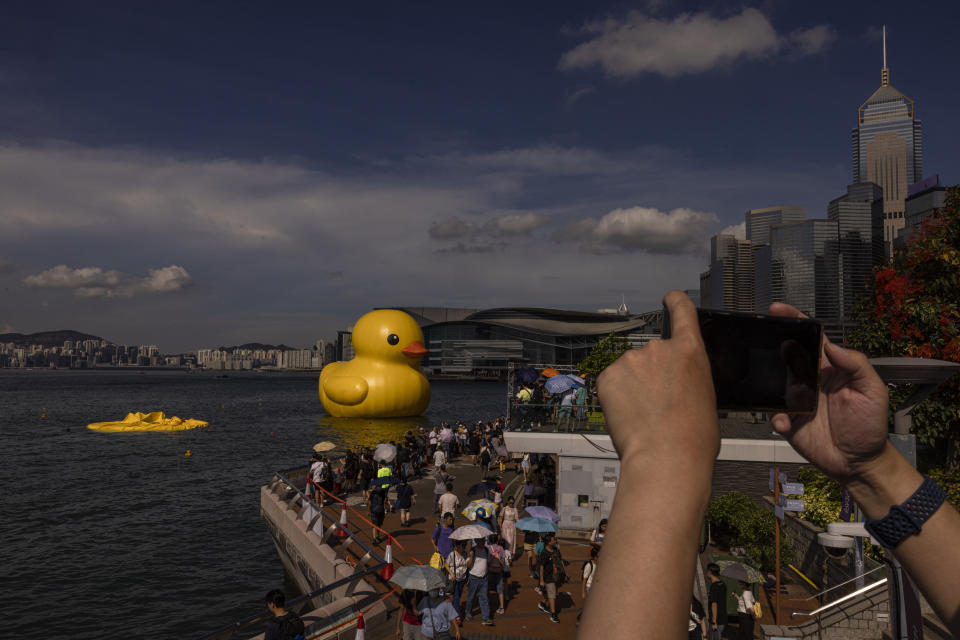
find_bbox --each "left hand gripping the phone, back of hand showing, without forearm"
[597,291,720,468]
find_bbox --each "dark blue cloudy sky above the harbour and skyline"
[0,1,960,352]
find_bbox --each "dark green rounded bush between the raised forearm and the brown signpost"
[707,491,794,571]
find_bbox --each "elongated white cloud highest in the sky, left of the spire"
[559,8,834,79]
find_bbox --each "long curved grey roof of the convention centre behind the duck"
[390,307,661,336]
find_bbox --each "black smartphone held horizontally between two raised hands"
[663,308,823,413]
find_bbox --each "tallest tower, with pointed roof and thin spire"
[852,27,923,256]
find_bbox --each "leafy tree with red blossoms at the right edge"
[848,187,960,473]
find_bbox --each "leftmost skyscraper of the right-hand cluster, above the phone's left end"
[700,234,753,311]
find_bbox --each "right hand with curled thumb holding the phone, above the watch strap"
[770,303,888,483]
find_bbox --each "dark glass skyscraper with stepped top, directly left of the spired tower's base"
[827,182,884,325]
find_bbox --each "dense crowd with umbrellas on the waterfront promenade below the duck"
[294,418,592,640]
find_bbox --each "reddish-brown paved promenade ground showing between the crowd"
[316,457,589,640]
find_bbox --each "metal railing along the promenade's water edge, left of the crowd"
[197,467,387,640]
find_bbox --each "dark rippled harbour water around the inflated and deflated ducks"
[0,369,506,640]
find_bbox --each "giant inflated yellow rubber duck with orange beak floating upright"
[320,309,430,418]
